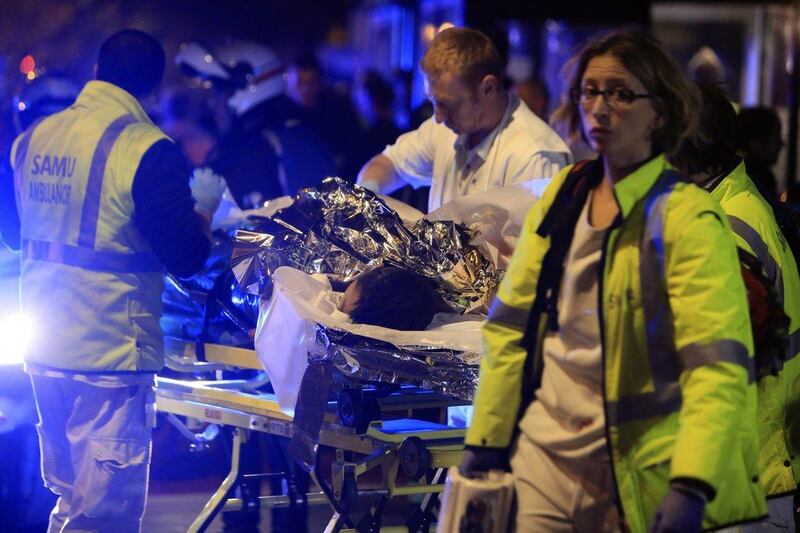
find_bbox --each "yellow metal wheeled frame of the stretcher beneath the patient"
[156,339,464,532]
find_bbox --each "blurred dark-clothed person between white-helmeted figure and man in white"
[287,54,359,182]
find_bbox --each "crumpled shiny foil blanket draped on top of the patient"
[231,178,499,310]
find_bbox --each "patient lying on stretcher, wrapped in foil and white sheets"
[165,179,548,420]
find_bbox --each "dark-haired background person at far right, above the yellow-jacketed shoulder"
[738,107,785,202]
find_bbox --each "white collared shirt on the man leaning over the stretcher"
[383,94,572,212]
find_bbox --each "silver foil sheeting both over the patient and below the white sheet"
[231,178,490,462]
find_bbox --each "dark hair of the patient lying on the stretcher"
[350,267,452,331]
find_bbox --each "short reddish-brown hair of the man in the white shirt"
[420,28,505,86]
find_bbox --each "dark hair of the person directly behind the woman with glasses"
[673,85,741,176]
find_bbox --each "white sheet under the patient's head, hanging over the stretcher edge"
[255,267,483,415]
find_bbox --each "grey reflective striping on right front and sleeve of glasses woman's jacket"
[607,170,755,425]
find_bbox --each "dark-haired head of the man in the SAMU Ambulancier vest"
[97,29,164,98]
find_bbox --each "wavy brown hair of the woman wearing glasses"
[553,30,701,155]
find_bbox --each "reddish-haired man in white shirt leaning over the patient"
[358,28,571,211]
